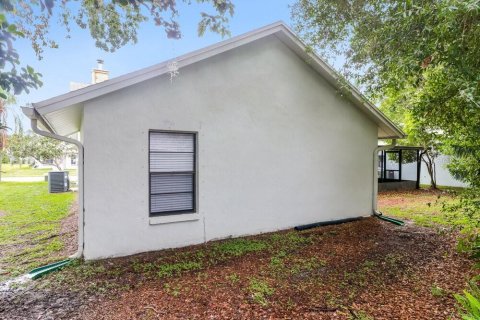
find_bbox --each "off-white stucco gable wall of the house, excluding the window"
[82,36,377,259]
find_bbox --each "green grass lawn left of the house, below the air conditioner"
[0,182,75,280]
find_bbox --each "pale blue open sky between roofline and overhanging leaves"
[8,0,295,128]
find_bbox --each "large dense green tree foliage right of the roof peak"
[292,0,480,245]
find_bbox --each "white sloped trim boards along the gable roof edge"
[33,21,405,139]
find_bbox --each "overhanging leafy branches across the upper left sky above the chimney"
[0,0,234,98]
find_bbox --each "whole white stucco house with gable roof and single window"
[24,23,404,259]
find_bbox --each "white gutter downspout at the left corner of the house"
[22,107,85,259]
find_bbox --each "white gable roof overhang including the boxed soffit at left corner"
[33,22,405,139]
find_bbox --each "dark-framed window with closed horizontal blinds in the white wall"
[149,131,196,215]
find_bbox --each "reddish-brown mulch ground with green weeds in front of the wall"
[75,218,475,319]
